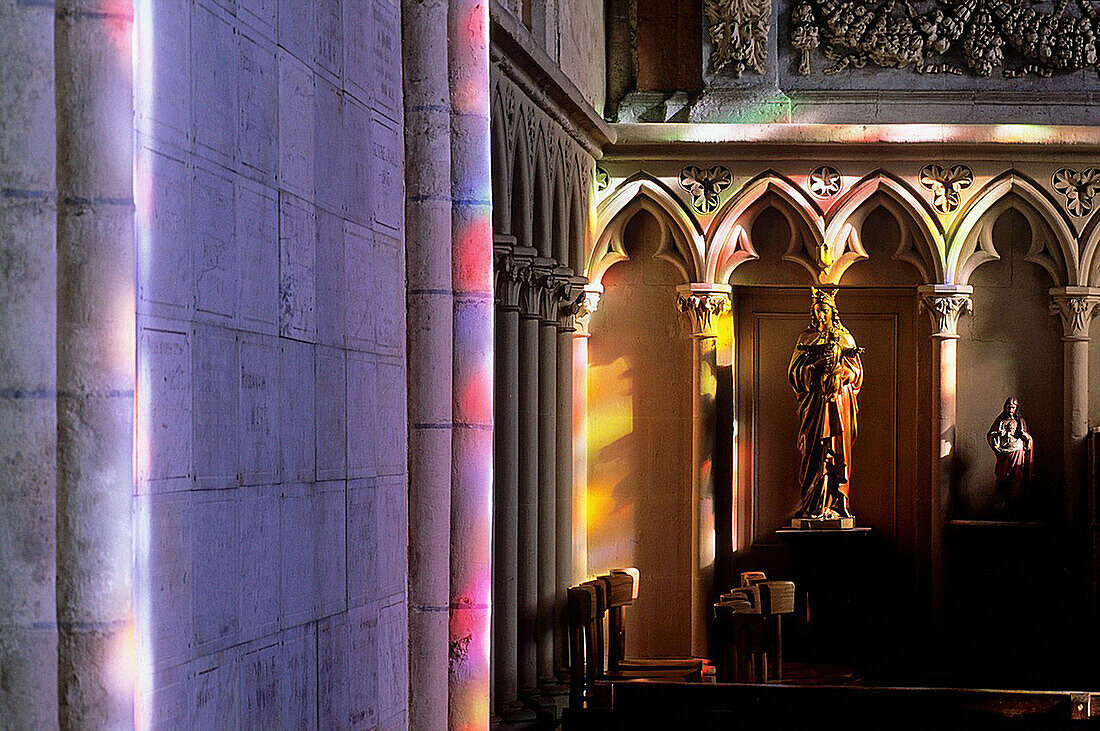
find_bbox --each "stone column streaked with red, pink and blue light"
[448,0,494,729]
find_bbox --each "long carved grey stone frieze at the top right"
[790,0,1100,78]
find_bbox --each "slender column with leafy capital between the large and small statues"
[917,285,974,624]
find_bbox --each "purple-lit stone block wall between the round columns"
[133,0,408,729]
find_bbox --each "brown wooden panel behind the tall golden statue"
[735,287,919,547]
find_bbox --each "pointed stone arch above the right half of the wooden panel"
[820,170,946,284]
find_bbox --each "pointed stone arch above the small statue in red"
[945,170,1082,286]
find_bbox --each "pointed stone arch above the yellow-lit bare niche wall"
[585,173,703,284]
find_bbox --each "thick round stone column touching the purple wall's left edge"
[56,0,135,729]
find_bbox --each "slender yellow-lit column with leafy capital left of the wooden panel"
[677,284,733,657]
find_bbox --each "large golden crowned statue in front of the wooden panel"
[788,288,864,528]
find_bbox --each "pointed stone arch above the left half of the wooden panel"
[704,170,825,283]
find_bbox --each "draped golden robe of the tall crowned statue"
[788,326,864,518]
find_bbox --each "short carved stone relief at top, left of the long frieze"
[703,0,771,77]
